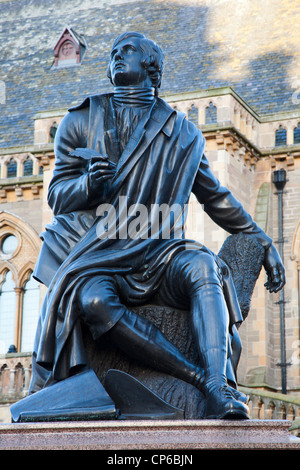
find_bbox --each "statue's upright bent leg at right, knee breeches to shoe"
[161,250,248,418]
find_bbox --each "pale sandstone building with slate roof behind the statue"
[0,0,300,420]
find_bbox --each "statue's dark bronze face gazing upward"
[109,37,152,87]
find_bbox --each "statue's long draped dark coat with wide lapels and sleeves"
[33,94,271,392]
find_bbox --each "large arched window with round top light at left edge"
[0,211,42,354]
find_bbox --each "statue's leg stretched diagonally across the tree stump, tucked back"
[78,276,204,388]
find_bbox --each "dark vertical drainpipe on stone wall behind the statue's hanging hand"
[273,168,288,394]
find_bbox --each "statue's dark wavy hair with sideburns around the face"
[107,31,164,89]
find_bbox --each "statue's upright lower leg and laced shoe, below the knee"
[191,284,249,419]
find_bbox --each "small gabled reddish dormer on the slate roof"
[54,27,87,67]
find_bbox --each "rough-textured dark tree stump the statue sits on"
[83,234,264,419]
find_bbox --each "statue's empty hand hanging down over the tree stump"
[264,244,285,292]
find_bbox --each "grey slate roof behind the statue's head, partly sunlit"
[0,0,300,148]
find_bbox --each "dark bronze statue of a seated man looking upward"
[30,32,285,419]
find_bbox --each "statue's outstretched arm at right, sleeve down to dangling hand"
[193,155,285,292]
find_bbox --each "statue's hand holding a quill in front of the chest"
[88,155,116,192]
